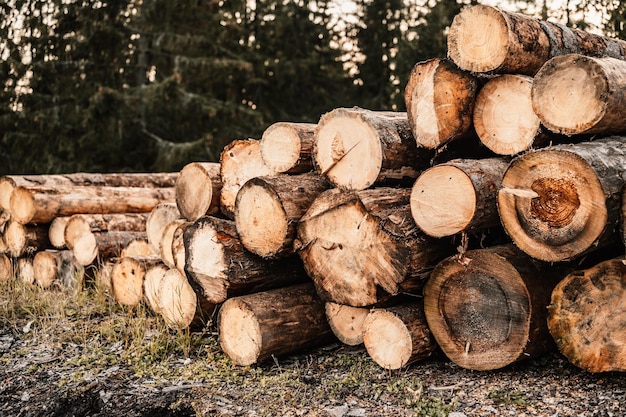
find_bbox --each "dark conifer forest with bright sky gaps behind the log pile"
[0,0,626,175]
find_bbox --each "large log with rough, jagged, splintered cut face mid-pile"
[294,187,453,307]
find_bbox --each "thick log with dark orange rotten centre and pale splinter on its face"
[498,137,626,262]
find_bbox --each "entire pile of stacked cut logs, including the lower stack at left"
[0,5,626,372]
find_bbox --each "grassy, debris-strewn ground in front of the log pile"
[0,274,626,417]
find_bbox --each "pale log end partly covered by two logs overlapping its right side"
[220,139,276,219]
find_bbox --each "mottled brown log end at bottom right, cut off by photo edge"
[548,258,626,372]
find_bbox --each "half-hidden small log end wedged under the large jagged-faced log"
[325,301,370,346]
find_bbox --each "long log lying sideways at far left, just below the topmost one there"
[10,186,174,224]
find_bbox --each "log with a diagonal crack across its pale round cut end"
[313,107,434,190]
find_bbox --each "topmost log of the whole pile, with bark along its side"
[448,5,626,75]
